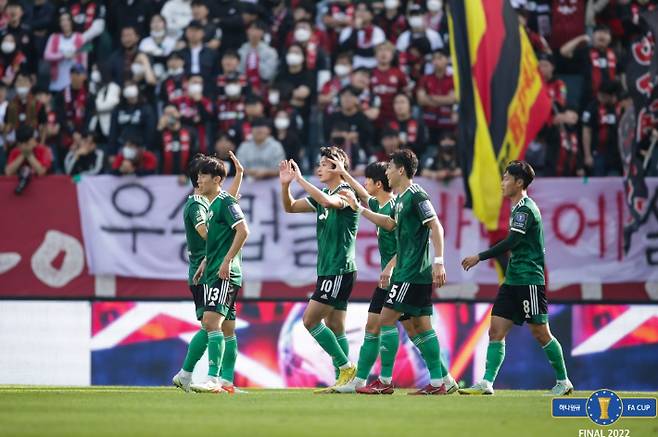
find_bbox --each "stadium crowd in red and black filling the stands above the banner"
[0,0,648,188]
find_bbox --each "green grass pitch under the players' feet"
[0,386,658,437]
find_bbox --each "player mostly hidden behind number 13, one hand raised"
[172,153,243,392]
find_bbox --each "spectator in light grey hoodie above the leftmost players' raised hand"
[237,118,286,179]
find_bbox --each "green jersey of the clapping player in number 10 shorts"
[306,183,359,276]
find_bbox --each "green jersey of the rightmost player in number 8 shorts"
[505,197,546,285]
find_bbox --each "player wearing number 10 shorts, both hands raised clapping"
[279,147,359,393]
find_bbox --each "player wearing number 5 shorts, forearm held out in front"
[342,149,457,395]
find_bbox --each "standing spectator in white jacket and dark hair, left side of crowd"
[88,64,121,146]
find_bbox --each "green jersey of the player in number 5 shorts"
[391,184,436,284]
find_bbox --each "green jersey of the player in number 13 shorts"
[204,191,244,287]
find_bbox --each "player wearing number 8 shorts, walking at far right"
[459,161,573,396]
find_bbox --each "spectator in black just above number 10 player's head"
[325,86,373,165]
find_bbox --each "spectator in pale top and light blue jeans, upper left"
[43,13,87,92]
